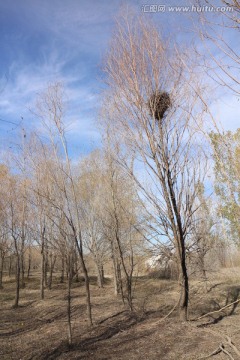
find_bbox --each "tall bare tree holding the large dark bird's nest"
[102,12,206,319]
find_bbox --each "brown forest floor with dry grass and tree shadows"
[0,268,240,360]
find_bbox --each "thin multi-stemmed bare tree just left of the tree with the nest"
[103,146,139,310]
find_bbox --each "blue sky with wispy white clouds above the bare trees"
[0,0,240,157]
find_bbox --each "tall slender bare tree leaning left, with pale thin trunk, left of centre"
[33,83,92,325]
